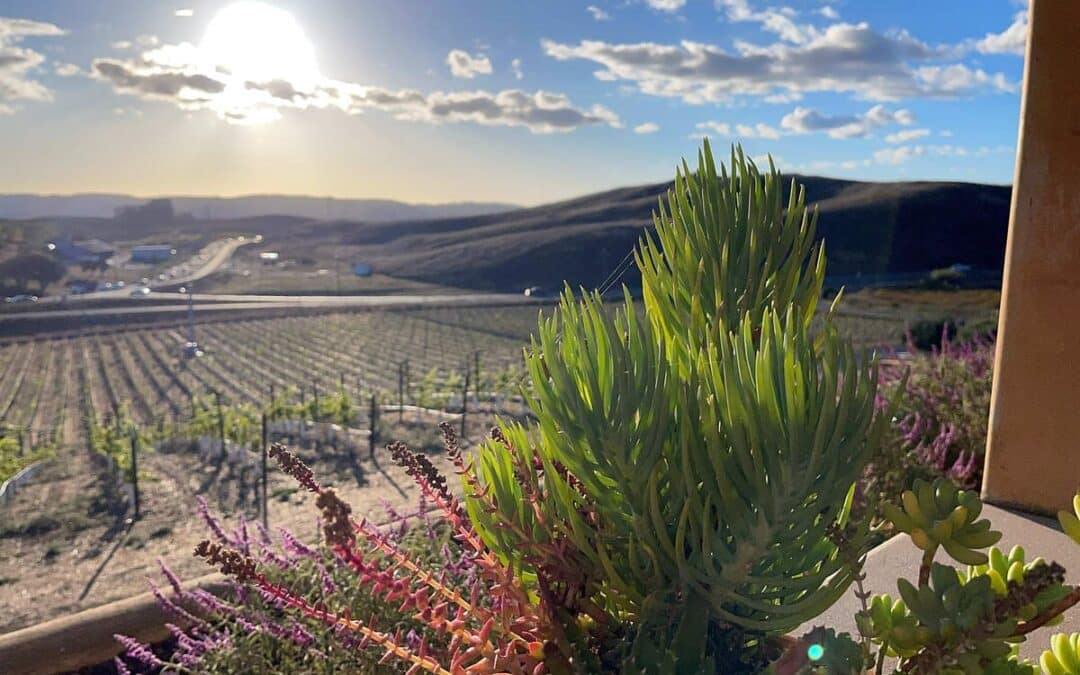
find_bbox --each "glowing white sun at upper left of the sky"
[200,0,320,86]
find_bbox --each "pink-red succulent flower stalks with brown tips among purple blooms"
[162,426,571,675]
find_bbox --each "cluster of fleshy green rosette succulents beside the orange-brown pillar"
[855,478,1080,675]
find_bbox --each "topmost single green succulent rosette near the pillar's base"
[883,478,1001,565]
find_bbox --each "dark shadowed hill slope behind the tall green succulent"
[345,176,1010,289]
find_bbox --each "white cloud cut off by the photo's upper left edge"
[0,16,66,108]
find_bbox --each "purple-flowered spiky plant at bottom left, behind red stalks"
[117,498,466,674]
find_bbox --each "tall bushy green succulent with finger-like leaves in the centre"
[465,143,886,673]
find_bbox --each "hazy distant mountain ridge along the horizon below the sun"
[0,194,517,222]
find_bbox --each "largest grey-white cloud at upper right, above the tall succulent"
[541,21,1016,104]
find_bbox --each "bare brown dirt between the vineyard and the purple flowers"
[0,411,511,634]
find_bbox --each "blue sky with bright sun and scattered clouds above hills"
[0,0,1027,204]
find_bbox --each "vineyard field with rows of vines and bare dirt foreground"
[0,296,995,632]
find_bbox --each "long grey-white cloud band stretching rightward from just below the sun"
[91,43,621,134]
